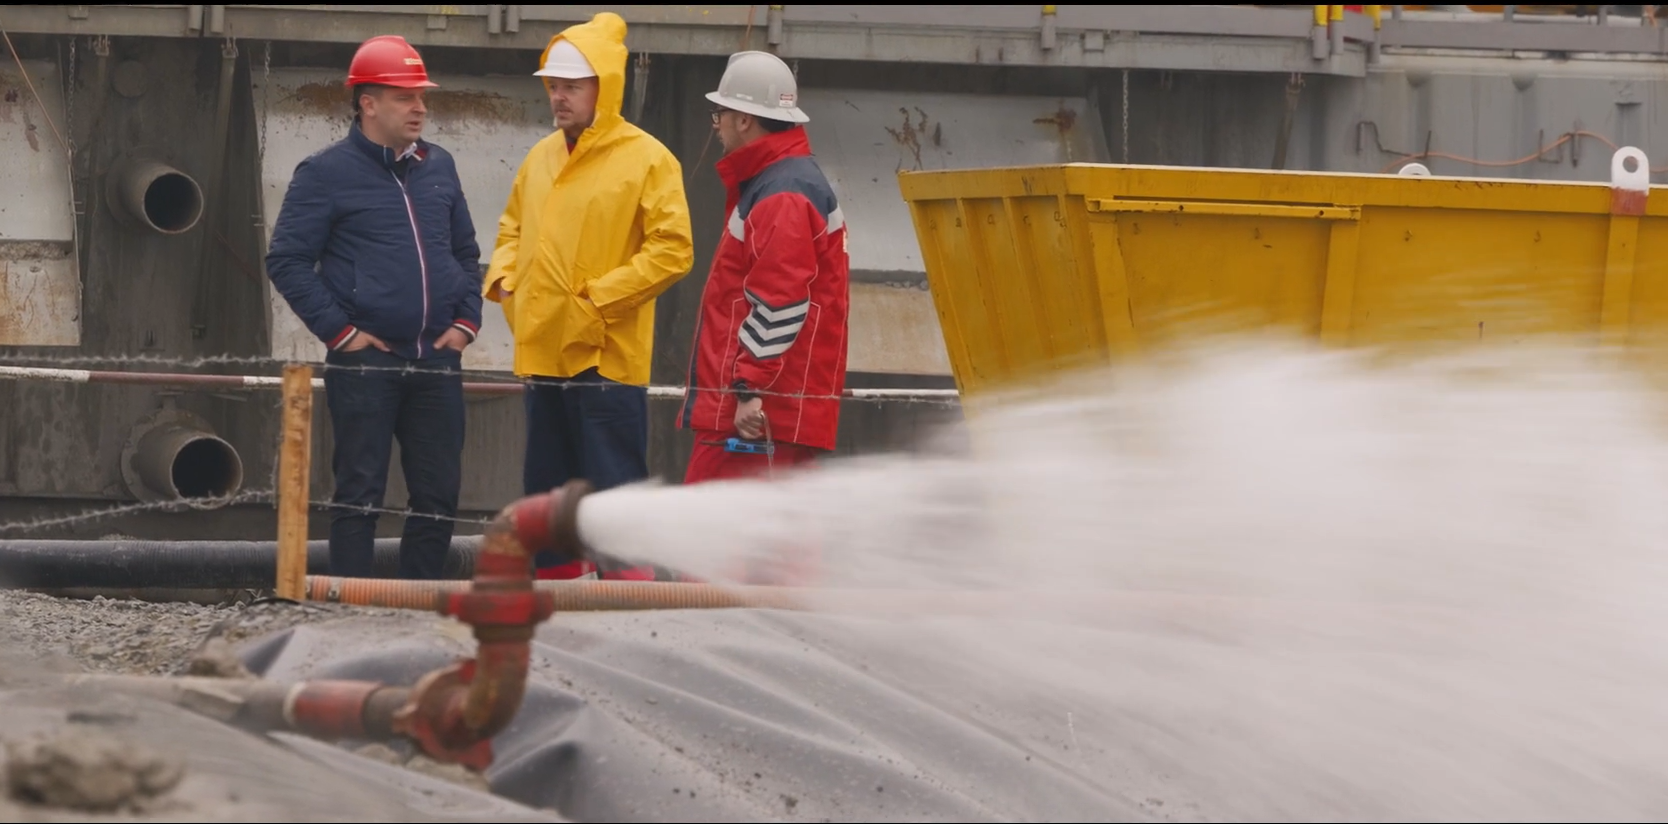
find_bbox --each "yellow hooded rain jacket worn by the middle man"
[484,12,696,385]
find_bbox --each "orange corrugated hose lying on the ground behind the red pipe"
[307,575,802,612]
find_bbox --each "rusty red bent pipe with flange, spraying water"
[66,480,589,771]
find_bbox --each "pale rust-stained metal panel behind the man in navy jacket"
[252,68,552,372]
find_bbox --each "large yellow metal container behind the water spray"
[899,147,1668,395]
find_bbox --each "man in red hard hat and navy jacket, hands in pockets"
[267,35,480,579]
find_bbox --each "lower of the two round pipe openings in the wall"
[127,415,244,509]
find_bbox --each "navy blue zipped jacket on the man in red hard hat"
[267,123,480,360]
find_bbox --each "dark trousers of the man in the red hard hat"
[324,347,464,580]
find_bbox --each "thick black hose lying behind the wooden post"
[0,535,480,589]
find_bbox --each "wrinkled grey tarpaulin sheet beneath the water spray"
[245,609,1134,822]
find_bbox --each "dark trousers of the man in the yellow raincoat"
[522,369,649,567]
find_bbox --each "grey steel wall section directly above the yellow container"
[1096,52,1668,183]
